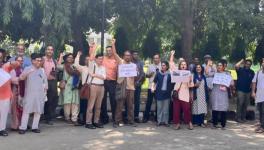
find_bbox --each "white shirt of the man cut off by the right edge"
[252,71,264,103]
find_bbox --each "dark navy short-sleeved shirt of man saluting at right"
[236,68,255,93]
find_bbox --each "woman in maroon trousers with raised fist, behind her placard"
[170,51,194,130]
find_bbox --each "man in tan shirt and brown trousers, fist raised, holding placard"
[113,48,137,127]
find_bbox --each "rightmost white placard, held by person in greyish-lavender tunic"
[213,73,232,87]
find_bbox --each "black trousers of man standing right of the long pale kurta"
[44,80,58,121]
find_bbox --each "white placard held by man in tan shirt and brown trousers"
[118,64,137,77]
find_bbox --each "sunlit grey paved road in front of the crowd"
[0,122,264,150]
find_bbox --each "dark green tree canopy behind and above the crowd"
[0,0,264,61]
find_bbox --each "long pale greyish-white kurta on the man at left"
[22,66,48,114]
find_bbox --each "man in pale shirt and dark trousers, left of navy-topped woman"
[143,54,161,123]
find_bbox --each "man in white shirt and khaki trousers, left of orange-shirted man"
[85,54,106,129]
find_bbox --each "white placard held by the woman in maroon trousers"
[171,70,191,83]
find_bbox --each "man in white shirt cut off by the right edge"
[252,59,264,133]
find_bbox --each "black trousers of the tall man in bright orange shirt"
[100,80,117,122]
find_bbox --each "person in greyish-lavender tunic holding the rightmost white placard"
[210,60,234,130]
